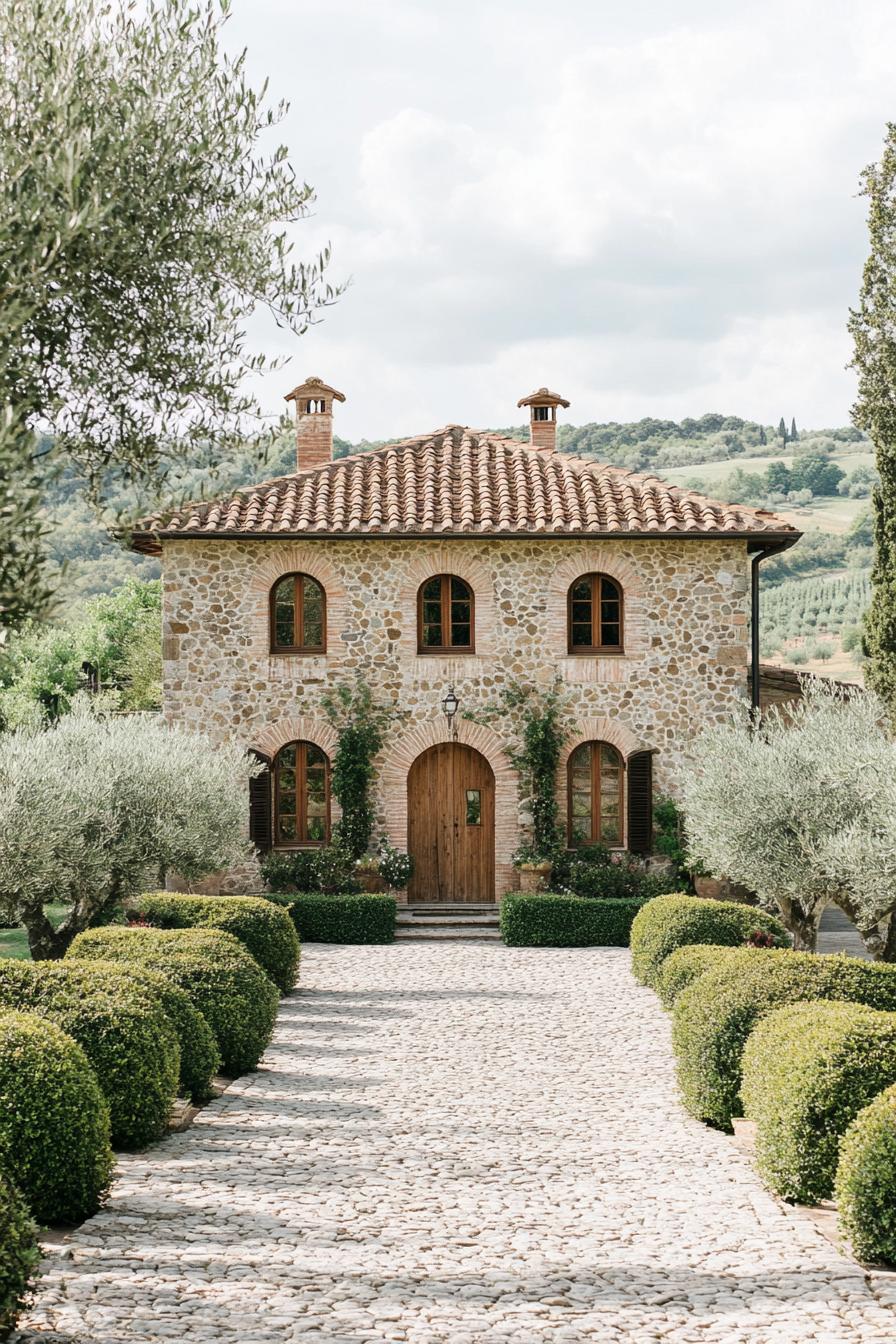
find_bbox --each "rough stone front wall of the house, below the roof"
[164,538,748,898]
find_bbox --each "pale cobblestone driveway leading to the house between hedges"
[12,943,896,1344]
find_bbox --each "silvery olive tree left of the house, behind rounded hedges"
[0,704,259,958]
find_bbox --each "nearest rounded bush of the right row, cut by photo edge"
[834,1087,896,1265]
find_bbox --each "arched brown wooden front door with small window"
[407,742,494,903]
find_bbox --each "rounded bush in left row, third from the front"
[0,961,180,1148]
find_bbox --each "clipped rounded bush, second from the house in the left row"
[70,925,278,1078]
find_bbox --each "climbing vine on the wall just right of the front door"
[469,681,567,863]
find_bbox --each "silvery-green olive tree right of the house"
[681,679,896,960]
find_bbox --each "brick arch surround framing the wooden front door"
[376,715,520,900]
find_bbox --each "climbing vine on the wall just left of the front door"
[322,679,391,859]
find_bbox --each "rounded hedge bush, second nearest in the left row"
[0,1012,113,1223]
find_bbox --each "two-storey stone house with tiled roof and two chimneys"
[133,378,799,902]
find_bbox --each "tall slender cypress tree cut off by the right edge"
[849,121,896,722]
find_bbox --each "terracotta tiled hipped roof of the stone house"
[132,425,799,552]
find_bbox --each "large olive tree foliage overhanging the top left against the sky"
[0,0,337,628]
